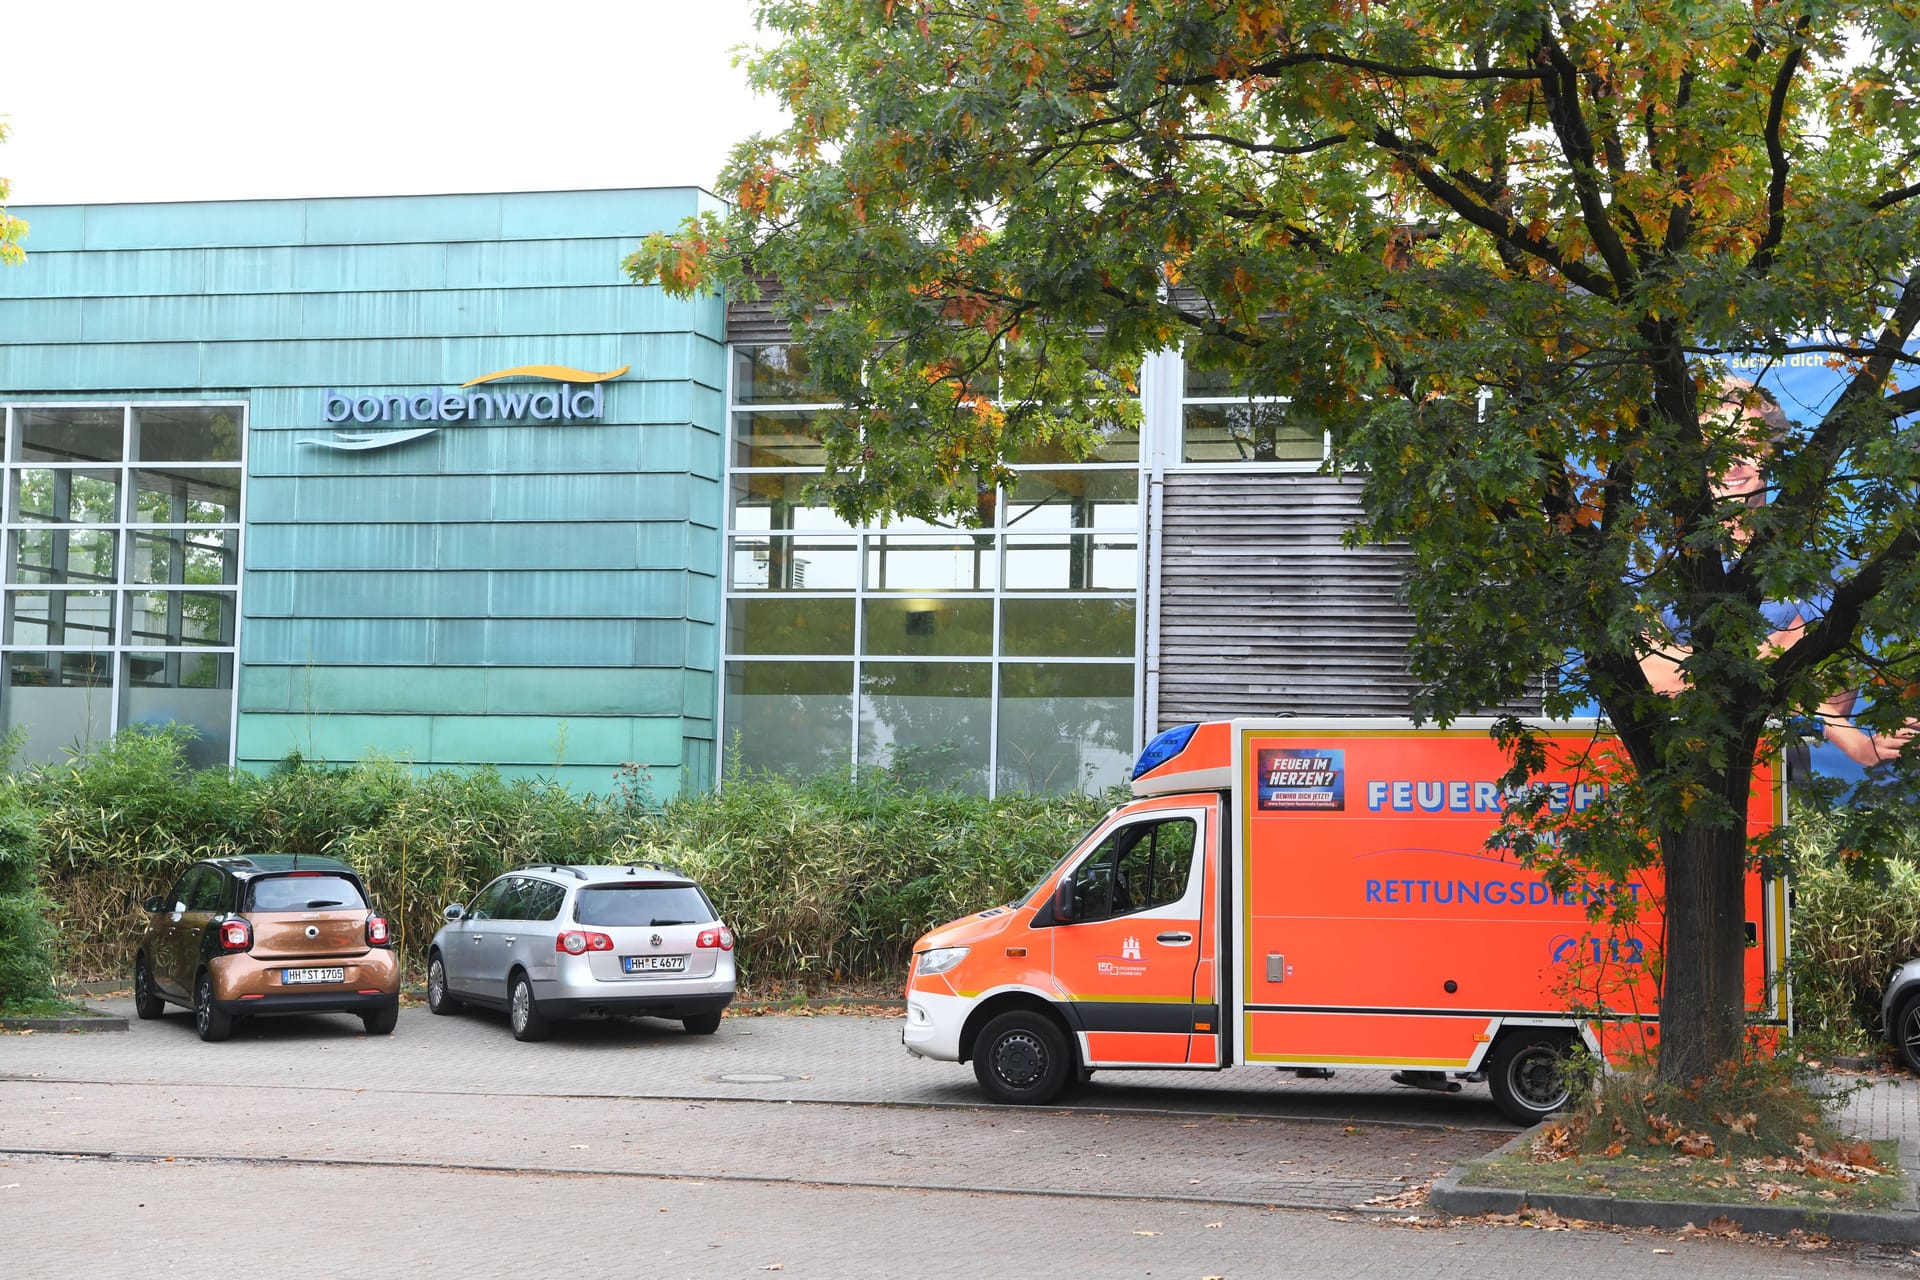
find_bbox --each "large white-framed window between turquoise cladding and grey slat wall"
[720,344,1144,793]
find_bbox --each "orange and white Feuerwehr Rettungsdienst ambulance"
[902,720,1788,1125]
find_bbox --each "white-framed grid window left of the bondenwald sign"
[0,405,246,766]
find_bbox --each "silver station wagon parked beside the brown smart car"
[426,864,733,1040]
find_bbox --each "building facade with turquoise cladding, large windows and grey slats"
[0,190,1409,794]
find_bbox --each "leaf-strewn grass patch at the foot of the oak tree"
[1461,1130,1908,1213]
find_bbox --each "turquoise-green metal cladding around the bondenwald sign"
[0,188,726,798]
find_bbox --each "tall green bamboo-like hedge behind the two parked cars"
[12,729,1106,988]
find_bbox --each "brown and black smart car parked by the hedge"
[132,854,399,1040]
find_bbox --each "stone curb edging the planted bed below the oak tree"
[1427,1121,1920,1245]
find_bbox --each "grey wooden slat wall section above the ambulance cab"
[1158,472,1413,727]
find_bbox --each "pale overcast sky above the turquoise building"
[0,0,780,208]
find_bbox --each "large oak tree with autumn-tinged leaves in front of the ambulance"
[628,0,1920,1079]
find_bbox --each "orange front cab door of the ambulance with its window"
[1035,802,1219,1067]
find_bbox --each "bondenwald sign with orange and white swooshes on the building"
[300,365,632,451]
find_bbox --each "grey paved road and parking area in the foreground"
[0,1002,1920,1280]
